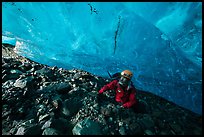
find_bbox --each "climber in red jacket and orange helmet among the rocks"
[99,70,137,108]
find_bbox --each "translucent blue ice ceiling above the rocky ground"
[2,2,202,114]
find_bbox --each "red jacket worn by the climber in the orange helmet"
[99,80,136,108]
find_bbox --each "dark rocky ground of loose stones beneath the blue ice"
[2,45,202,135]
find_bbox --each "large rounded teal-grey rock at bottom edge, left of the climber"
[72,118,101,135]
